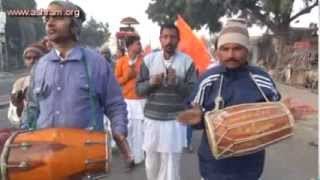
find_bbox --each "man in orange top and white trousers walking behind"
[115,35,144,164]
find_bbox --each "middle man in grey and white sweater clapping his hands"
[136,24,197,180]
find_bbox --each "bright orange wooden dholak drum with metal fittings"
[0,128,110,180]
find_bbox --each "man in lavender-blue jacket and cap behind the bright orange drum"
[22,1,132,169]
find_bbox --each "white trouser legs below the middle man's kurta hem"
[145,151,181,180]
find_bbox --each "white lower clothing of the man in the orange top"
[125,99,145,163]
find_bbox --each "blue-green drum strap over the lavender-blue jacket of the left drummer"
[81,48,97,130]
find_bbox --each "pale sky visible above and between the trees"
[36,0,319,48]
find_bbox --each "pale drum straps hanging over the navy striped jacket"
[214,72,270,111]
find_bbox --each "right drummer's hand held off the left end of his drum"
[177,104,203,125]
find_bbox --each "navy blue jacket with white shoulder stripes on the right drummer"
[189,65,280,179]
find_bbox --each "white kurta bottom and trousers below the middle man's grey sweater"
[143,118,187,180]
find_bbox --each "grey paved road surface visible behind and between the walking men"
[0,72,319,180]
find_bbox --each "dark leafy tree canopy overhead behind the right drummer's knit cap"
[146,0,319,34]
